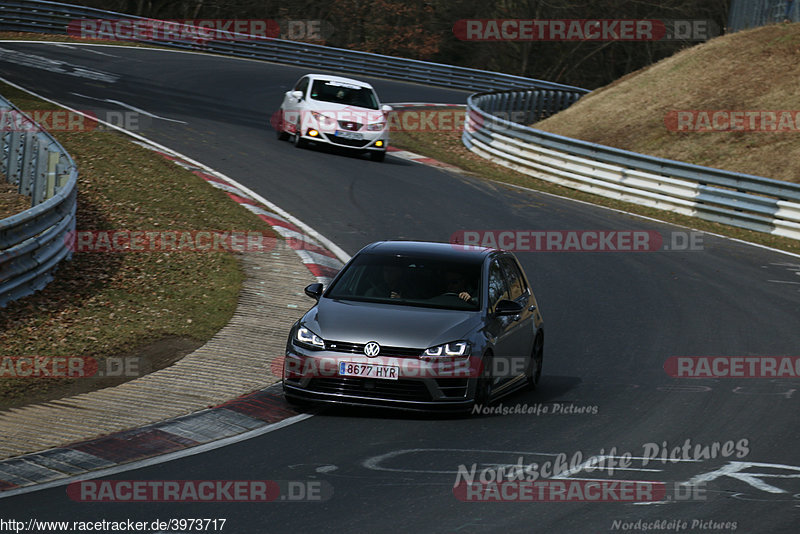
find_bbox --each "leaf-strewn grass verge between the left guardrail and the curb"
[0,84,275,409]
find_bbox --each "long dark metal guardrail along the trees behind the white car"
[0,0,579,91]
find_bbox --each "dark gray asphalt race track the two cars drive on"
[0,42,800,533]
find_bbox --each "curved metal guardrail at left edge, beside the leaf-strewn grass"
[0,96,78,307]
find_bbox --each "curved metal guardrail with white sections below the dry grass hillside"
[462,90,800,239]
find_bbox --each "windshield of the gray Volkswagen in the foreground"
[325,254,481,311]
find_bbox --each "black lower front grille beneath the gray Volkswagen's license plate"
[307,377,432,402]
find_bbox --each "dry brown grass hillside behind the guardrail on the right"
[535,23,800,182]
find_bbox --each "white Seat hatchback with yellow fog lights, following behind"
[273,74,392,161]
